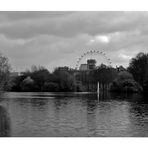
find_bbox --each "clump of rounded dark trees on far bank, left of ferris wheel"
[10,66,75,92]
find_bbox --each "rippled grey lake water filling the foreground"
[0,93,148,137]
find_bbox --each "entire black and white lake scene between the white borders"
[0,11,148,137]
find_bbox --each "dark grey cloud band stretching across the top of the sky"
[0,12,147,38]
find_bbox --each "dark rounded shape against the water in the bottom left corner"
[0,106,10,137]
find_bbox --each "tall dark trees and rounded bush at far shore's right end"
[110,53,148,94]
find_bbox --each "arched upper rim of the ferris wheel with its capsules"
[75,50,112,70]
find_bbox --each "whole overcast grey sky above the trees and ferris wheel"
[0,12,148,71]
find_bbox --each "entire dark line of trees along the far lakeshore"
[0,50,148,94]
